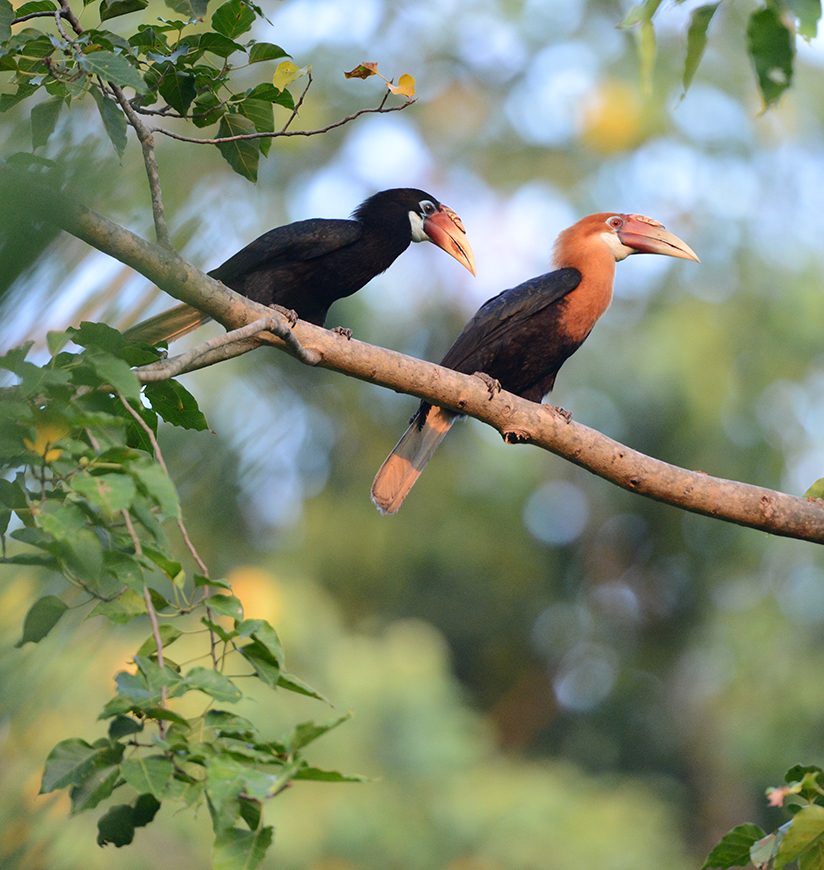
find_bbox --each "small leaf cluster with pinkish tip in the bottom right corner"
[701,764,824,870]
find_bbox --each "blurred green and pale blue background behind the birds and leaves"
[0,0,824,870]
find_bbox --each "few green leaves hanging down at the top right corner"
[622,0,821,107]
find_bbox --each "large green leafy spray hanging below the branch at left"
[0,323,358,868]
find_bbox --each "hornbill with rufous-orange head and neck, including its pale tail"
[372,212,698,514]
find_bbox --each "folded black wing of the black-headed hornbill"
[209,218,363,283]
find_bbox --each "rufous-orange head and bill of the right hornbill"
[554,212,700,267]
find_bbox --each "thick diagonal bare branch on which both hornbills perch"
[11,171,824,544]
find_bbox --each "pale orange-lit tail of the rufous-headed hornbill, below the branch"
[372,407,458,514]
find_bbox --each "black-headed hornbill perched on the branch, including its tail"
[125,187,475,344]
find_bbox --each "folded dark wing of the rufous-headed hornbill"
[441,269,581,374]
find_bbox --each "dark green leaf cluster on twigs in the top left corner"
[0,0,295,181]
